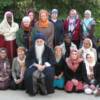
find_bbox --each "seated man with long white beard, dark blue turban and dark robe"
[25,33,55,96]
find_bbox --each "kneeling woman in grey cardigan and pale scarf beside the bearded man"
[10,47,26,90]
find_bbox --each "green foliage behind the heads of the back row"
[0,0,100,21]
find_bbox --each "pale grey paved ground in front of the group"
[0,90,100,100]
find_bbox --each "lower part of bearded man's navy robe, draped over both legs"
[24,66,54,95]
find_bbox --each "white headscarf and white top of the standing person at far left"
[0,11,19,40]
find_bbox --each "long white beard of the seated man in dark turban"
[35,45,44,64]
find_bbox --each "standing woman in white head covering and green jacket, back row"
[16,16,33,50]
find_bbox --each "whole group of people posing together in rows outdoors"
[0,9,100,96]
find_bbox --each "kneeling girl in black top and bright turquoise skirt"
[54,46,64,89]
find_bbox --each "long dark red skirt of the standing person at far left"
[5,40,17,64]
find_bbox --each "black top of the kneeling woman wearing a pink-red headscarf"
[64,62,89,83]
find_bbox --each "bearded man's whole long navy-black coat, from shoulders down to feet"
[24,45,55,95]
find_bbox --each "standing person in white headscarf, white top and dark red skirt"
[0,11,19,63]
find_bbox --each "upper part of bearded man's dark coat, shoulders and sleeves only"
[25,45,55,67]
